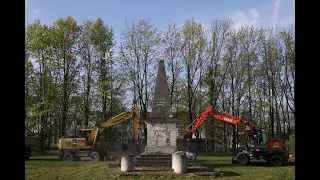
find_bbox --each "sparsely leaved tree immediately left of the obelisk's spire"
[120,20,160,141]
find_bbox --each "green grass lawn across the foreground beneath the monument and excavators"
[25,154,295,180]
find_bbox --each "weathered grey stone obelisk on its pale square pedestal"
[145,60,178,154]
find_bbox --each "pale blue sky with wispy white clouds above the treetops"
[25,0,295,42]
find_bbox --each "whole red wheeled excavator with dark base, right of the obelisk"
[184,106,289,166]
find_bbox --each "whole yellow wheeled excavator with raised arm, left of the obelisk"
[58,106,140,161]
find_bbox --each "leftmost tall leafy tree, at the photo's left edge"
[26,20,55,154]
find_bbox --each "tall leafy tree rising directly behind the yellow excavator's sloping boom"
[89,18,116,139]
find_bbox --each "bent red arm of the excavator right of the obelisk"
[184,106,257,135]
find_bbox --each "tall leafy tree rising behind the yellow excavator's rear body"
[52,16,80,135]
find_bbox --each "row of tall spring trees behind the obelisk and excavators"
[25,16,295,155]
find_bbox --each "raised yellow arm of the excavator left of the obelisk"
[88,106,140,145]
